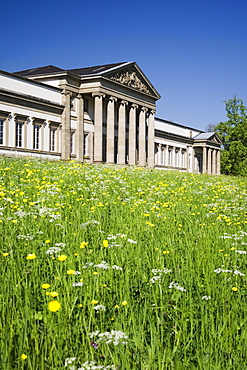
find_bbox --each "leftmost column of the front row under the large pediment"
[92,92,105,163]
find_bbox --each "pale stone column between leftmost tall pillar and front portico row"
[75,94,84,162]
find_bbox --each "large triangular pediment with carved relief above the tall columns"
[103,62,160,99]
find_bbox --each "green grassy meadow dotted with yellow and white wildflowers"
[0,157,247,370]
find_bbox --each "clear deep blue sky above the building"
[0,0,247,130]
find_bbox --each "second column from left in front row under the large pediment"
[106,96,117,163]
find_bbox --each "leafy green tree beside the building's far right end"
[215,95,247,176]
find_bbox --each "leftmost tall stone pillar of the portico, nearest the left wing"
[61,89,71,160]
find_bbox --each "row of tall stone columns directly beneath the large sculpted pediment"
[92,92,155,167]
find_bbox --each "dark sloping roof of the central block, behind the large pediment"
[14,62,127,77]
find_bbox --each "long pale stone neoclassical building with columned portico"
[0,62,221,174]
